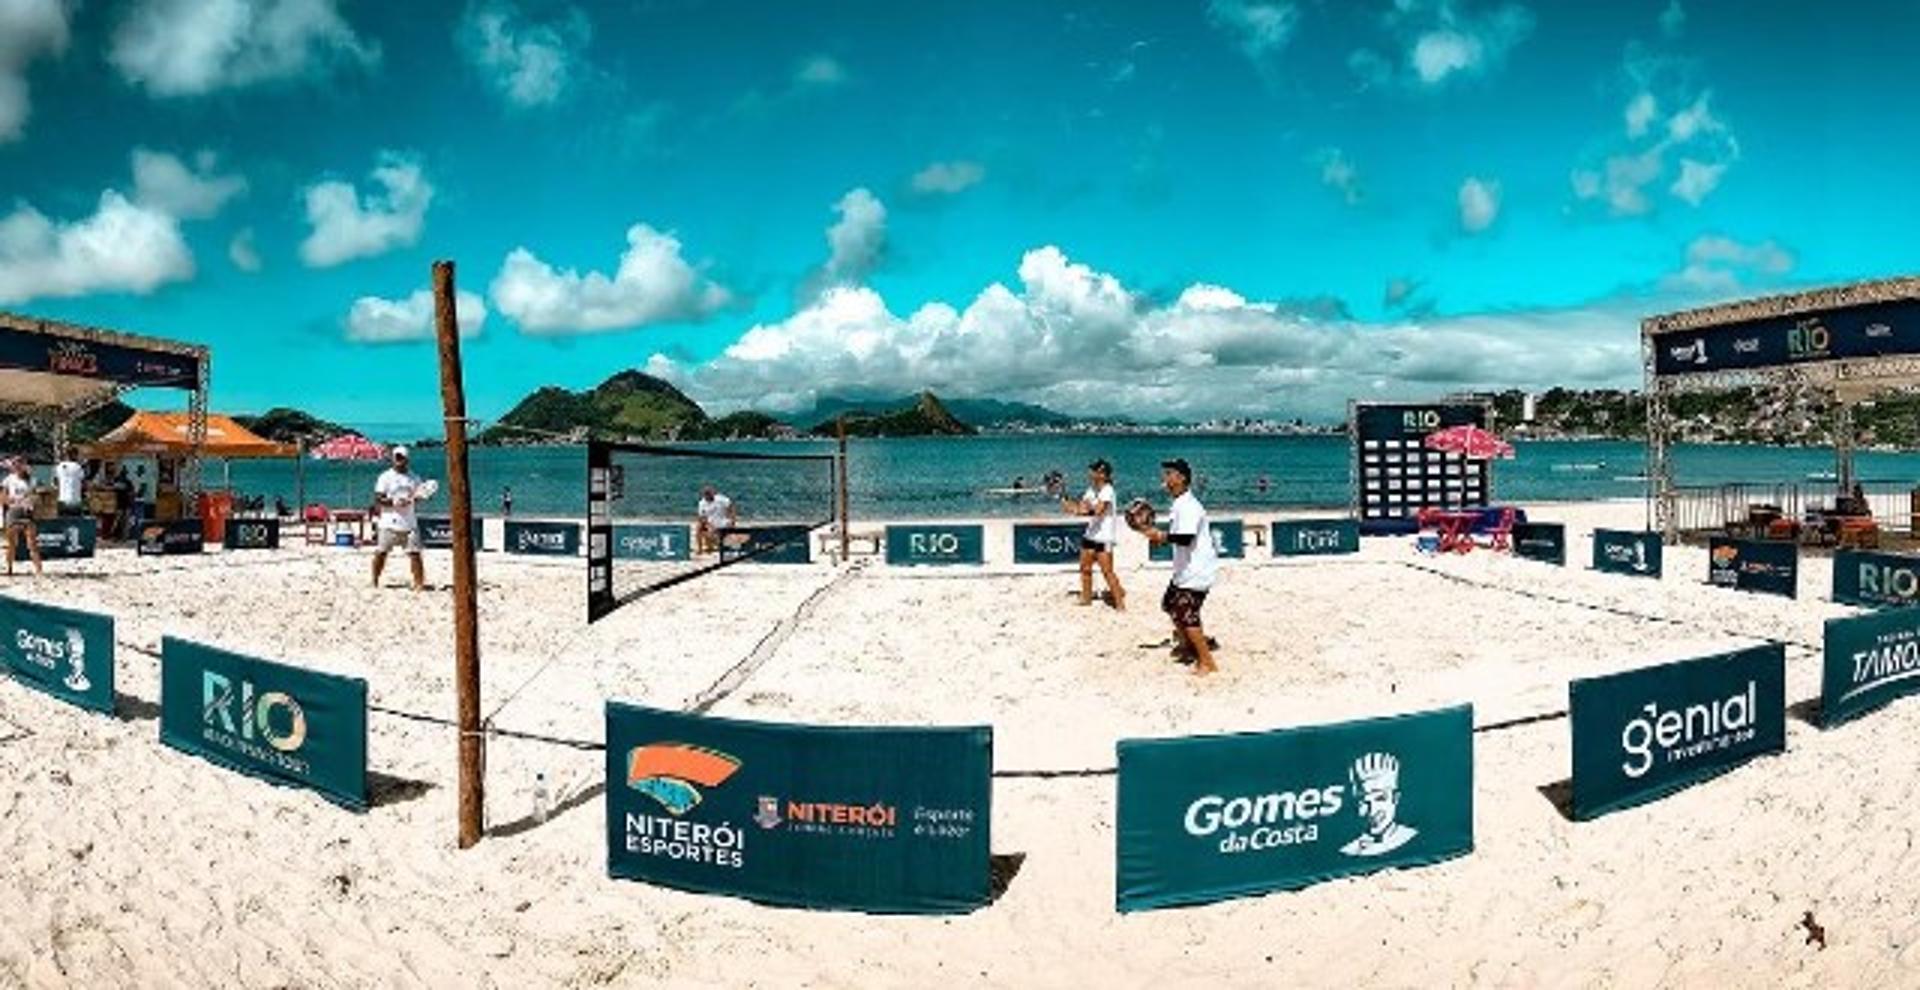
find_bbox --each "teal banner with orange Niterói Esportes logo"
[607,702,993,913]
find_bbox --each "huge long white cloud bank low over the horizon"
[649,248,1645,418]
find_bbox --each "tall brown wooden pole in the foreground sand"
[434,261,486,850]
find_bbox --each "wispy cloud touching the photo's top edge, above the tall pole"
[455,0,593,109]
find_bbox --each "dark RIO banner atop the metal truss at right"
[1653,299,1920,374]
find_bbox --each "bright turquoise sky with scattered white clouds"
[0,0,1920,436]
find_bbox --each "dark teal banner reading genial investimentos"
[1567,643,1788,821]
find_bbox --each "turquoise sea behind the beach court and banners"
[207,434,1920,518]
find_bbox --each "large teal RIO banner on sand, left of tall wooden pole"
[159,637,367,812]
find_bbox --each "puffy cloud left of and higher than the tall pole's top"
[300,152,434,269]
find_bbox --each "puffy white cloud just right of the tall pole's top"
[488,223,733,334]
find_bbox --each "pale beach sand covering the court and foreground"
[0,503,1920,988]
